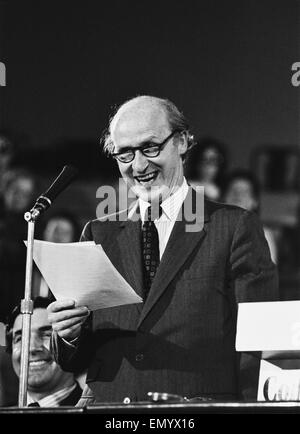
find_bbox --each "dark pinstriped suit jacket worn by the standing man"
[53,189,278,402]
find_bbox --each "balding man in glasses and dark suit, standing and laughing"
[48,96,278,403]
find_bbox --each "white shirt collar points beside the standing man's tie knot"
[138,178,189,222]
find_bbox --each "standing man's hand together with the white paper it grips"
[29,240,142,341]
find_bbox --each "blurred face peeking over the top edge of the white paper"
[44,217,77,243]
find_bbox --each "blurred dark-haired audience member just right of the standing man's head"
[185,138,226,200]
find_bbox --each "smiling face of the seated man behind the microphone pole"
[12,308,71,393]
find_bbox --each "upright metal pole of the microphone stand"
[18,217,35,407]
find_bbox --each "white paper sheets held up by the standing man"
[25,240,143,310]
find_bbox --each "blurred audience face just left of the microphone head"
[4,176,35,212]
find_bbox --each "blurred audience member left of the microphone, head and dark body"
[0,169,38,321]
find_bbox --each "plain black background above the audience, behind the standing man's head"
[0,0,300,179]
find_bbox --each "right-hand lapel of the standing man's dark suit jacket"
[138,189,209,327]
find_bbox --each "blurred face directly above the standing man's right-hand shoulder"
[224,178,258,211]
